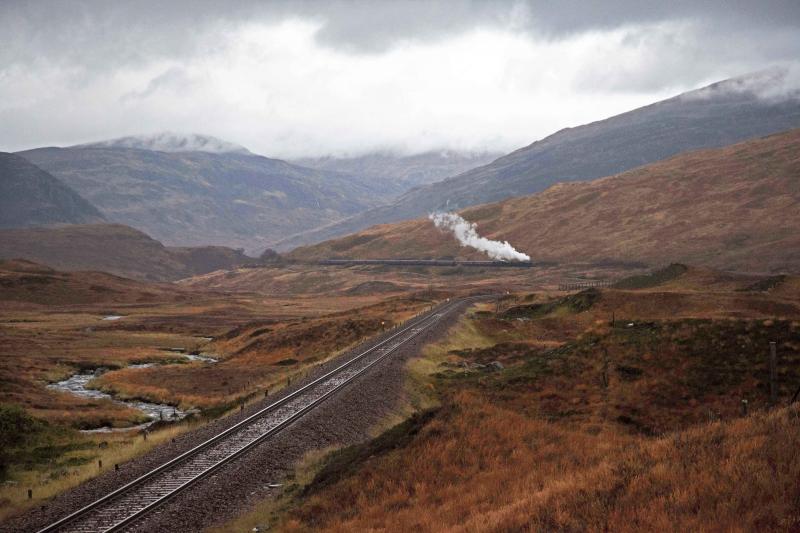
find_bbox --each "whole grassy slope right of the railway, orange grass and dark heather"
[244,268,800,531]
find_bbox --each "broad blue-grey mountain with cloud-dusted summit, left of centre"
[19,136,396,254]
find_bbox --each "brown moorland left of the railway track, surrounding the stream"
[0,261,476,519]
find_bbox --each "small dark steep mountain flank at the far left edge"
[0,152,103,228]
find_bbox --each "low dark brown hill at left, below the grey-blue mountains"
[0,224,256,281]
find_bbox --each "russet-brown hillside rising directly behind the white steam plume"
[290,129,800,272]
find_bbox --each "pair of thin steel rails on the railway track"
[39,297,480,533]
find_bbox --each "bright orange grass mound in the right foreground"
[284,392,800,531]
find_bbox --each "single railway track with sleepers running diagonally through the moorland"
[40,298,471,533]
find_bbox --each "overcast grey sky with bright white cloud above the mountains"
[0,0,800,158]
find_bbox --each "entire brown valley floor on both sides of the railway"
[0,265,800,531]
